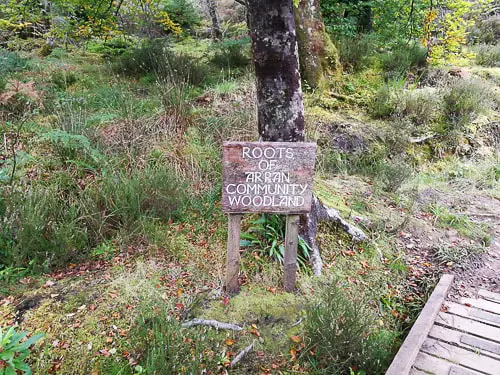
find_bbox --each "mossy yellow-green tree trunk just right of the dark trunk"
[296,0,341,89]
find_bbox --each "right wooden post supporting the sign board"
[284,215,300,292]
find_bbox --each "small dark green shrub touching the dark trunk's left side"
[211,37,250,69]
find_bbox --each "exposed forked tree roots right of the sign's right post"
[301,196,366,276]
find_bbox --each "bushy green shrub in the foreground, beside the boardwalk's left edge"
[303,280,396,374]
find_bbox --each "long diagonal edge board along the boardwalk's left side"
[386,274,453,375]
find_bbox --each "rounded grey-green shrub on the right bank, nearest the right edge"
[443,79,492,131]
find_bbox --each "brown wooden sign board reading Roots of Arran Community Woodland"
[222,142,316,214]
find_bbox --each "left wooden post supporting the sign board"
[226,214,242,293]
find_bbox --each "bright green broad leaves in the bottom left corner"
[0,326,44,375]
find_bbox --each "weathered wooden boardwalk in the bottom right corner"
[386,275,500,375]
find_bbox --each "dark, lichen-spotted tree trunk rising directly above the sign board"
[248,0,304,142]
